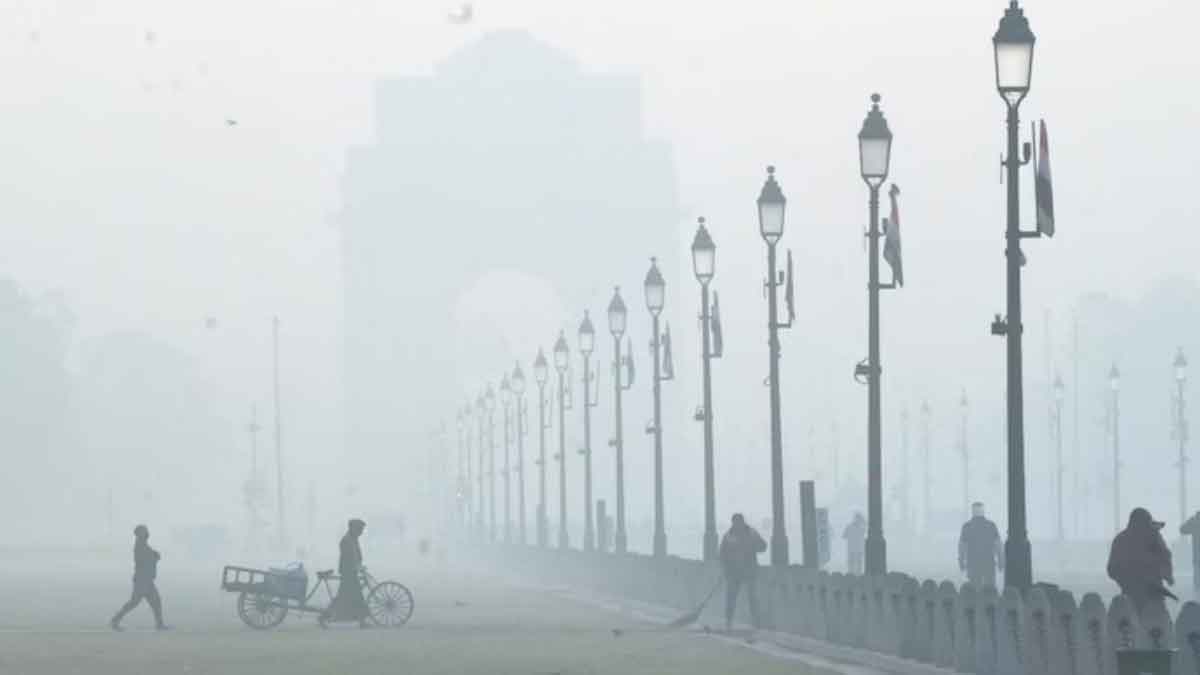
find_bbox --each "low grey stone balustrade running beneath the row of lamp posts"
[496,548,1200,675]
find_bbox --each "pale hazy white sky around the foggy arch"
[0,0,1200,547]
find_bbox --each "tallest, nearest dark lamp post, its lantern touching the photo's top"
[992,0,1039,591]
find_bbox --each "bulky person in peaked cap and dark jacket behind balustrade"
[1108,507,1177,615]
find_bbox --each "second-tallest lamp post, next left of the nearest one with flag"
[858,94,895,575]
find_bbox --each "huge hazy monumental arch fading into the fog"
[341,31,685,487]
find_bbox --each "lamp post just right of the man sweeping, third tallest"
[758,167,794,567]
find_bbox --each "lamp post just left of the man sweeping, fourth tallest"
[691,217,719,561]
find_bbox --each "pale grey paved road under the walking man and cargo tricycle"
[0,552,829,675]
